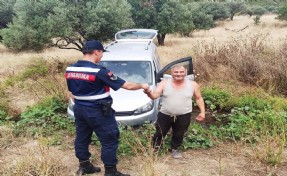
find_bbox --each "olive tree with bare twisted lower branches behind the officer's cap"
[49,0,133,50]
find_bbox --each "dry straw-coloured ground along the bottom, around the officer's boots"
[0,140,287,176]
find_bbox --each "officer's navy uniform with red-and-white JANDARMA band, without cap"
[65,60,125,166]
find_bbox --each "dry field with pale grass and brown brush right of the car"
[159,15,287,95]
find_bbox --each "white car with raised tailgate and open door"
[68,29,193,125]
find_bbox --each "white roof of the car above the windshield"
[101,41,156,61]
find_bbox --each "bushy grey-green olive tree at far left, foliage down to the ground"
[1,0,59,51]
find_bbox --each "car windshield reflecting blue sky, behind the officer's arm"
[100,61,152,84]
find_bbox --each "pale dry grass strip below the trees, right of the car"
[159,15,287,65]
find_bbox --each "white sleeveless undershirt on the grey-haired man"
[160,79,194,116]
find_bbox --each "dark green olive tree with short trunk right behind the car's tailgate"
[129,0,194,45]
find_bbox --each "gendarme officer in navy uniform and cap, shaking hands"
[65,40,149,176]
